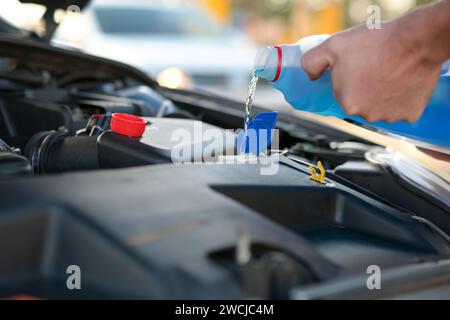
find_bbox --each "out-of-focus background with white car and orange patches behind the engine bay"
[0,0,436,109]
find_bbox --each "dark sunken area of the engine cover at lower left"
[0,207,160,299]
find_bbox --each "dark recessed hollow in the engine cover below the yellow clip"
[211,185,448,269]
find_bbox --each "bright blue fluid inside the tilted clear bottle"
[260,67,450,148]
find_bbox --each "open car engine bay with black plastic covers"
[0,39,450,299]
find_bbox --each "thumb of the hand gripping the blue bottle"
[301,41,332,80]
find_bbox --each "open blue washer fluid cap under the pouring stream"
[236,111,278,155]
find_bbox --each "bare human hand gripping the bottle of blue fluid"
[301,20,441,122]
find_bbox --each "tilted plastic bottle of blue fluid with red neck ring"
[255,34,450,153]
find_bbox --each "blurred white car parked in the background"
[53,0,276,100]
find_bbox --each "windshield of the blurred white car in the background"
[95,7,223,36]
